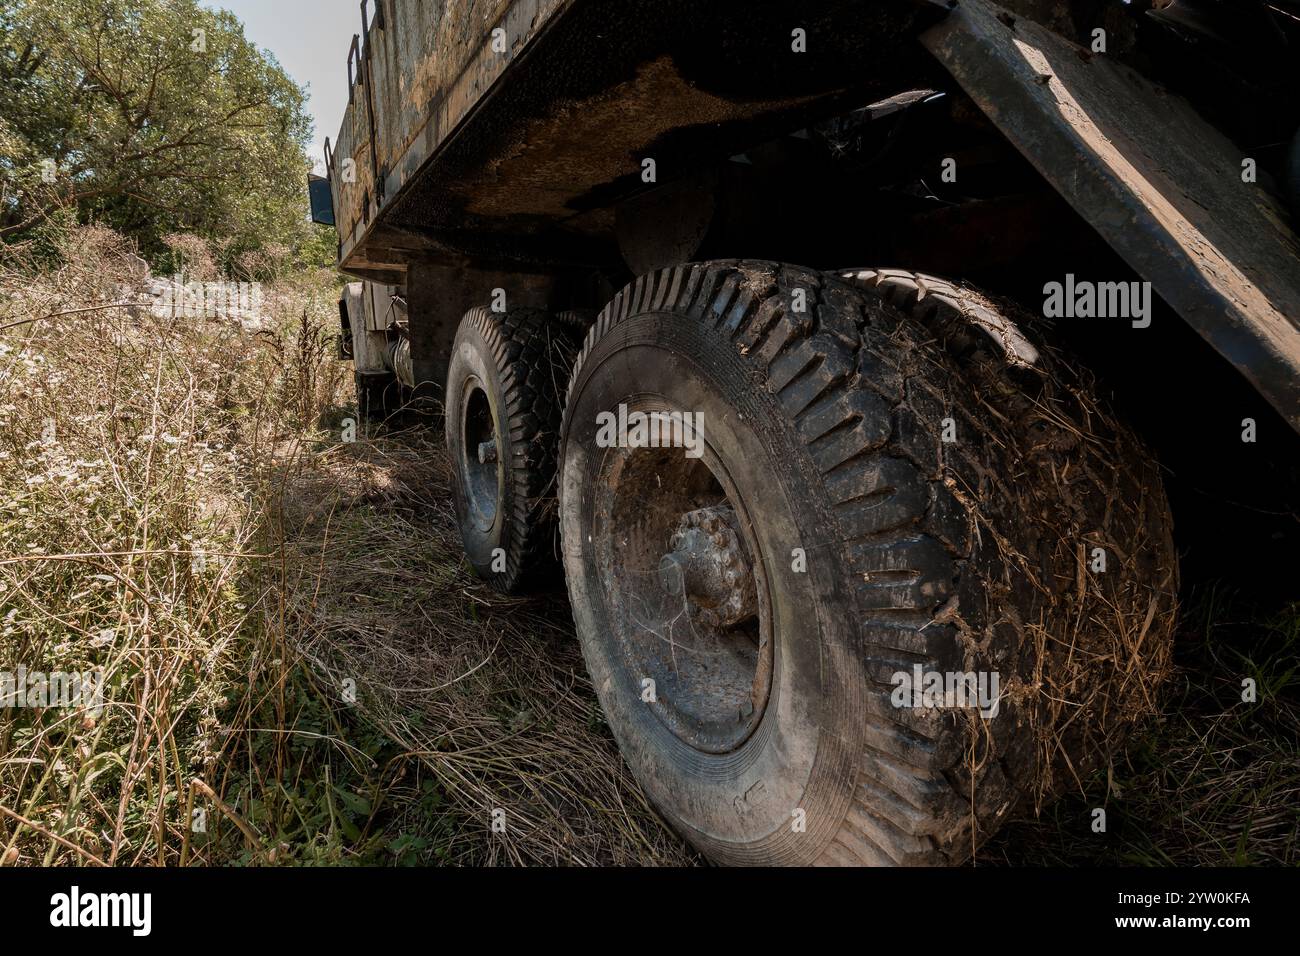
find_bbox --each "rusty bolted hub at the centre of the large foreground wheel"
[659,506,758,628]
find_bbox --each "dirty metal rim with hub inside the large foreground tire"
[592,397,774,754]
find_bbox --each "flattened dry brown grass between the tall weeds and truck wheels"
[281,432,692,865]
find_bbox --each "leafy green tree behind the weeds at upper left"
[0,0,322,265]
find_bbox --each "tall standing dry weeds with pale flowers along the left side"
[0,229,432,865]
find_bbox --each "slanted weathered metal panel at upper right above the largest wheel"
[922,0,1300,431]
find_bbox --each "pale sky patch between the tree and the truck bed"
[203,0,358,173]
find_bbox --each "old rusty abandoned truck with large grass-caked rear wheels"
[311,0,1300,865]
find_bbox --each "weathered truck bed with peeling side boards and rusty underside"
[329,0,943,281]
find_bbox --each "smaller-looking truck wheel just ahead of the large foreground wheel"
[445,308,577,593]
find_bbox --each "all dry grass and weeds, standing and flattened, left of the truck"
[0,229,690,865]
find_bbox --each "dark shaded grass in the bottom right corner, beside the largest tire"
[982,585,1300,866]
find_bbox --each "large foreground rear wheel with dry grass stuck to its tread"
[560,261,1177,865]
